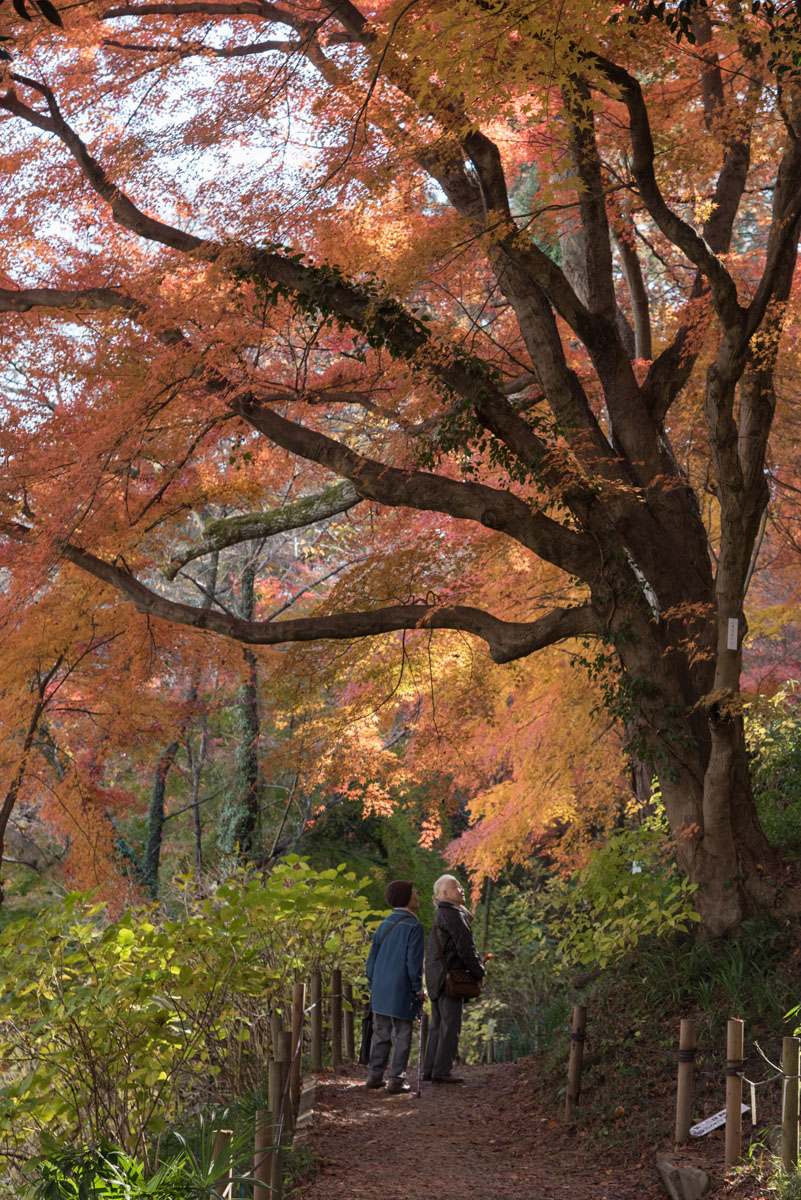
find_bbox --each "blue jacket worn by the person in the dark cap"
[367,908,424,1021]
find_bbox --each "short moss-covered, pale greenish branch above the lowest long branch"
[163,480,361,580]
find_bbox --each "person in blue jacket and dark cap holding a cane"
[367,880,424,1096]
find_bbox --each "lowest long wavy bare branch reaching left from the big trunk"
[64,545,602,662]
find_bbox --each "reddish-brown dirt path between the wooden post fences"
[293,1063,664,1200]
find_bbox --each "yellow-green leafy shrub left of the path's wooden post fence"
[0,858,369,1176]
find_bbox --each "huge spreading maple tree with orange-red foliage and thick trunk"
[0,0,801,934]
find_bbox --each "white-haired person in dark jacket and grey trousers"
[423,875,484,1084]
